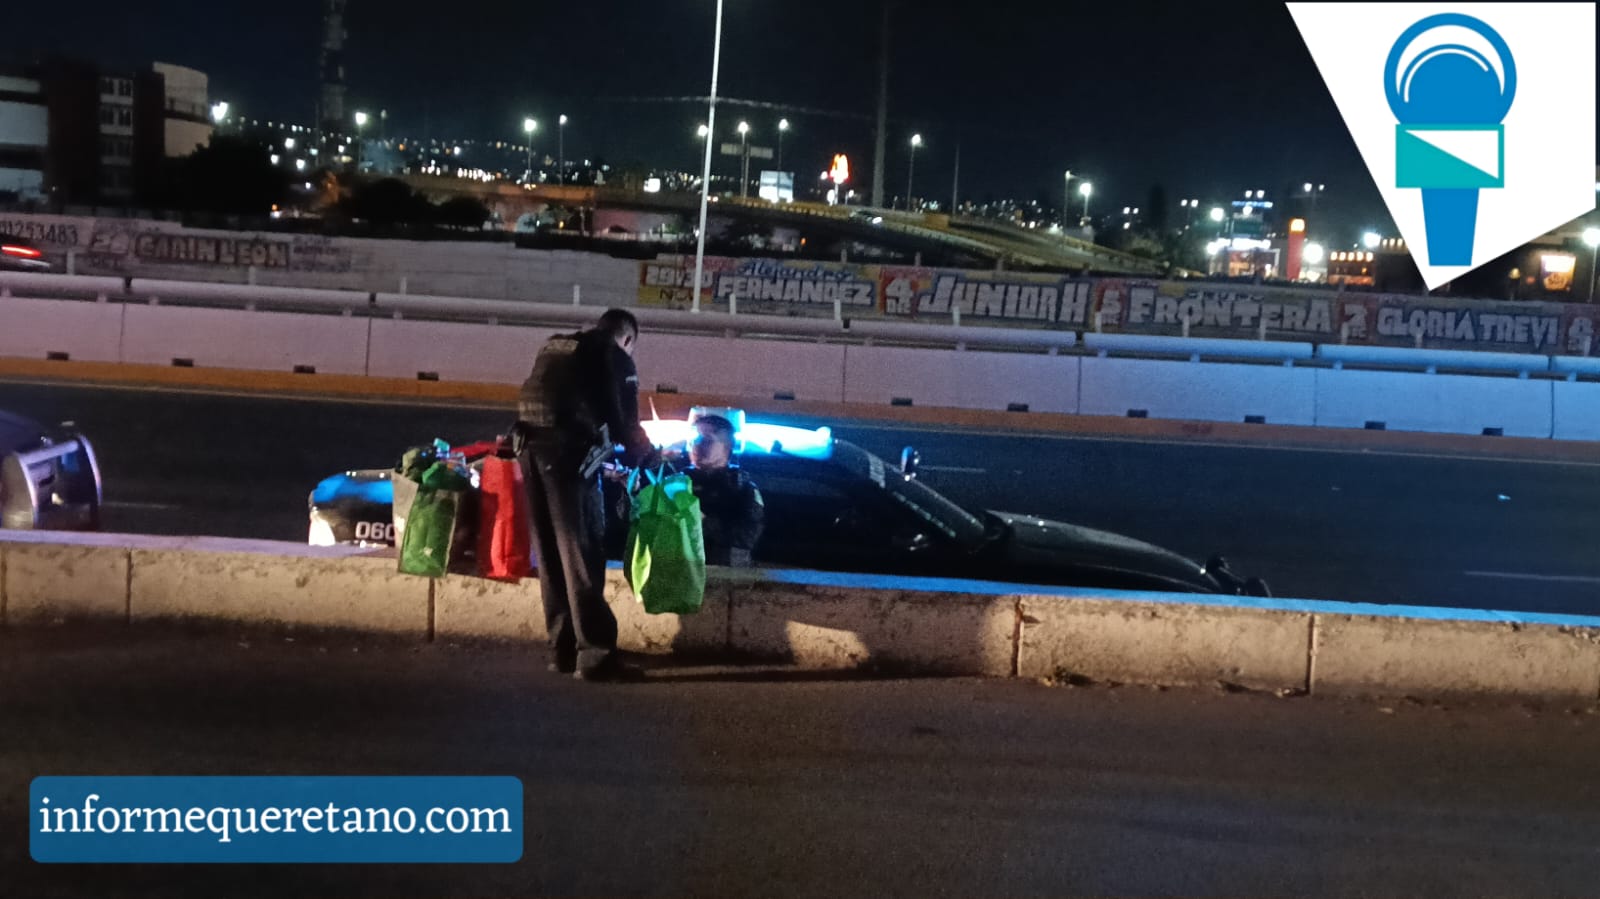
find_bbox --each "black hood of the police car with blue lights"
[989,512,1219,593]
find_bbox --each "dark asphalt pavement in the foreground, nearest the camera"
[0,625,1600,897]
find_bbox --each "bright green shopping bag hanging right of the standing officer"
[624,463,706,614]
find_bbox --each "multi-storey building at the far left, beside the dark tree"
[0,59,211,205]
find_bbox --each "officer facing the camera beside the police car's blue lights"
[688,416,766,566]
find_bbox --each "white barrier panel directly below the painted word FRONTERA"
[1078,357,1317,426]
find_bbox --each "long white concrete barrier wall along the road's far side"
[9,287,1600,440]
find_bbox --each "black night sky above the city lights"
[0,0,1465,243]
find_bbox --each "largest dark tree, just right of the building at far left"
[168,136,288,216]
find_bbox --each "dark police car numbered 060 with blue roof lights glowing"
[310,410,1270,597]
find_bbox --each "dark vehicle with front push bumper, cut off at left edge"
[0,411,101,531]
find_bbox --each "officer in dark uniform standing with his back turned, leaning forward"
[517,309,659,680]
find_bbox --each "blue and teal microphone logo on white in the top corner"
[1384,13,1517,267]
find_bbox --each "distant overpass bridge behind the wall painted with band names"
[402,174,1165,275]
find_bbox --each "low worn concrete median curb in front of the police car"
[0,531,1600,702]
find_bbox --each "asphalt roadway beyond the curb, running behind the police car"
[0,382,1600,614]
